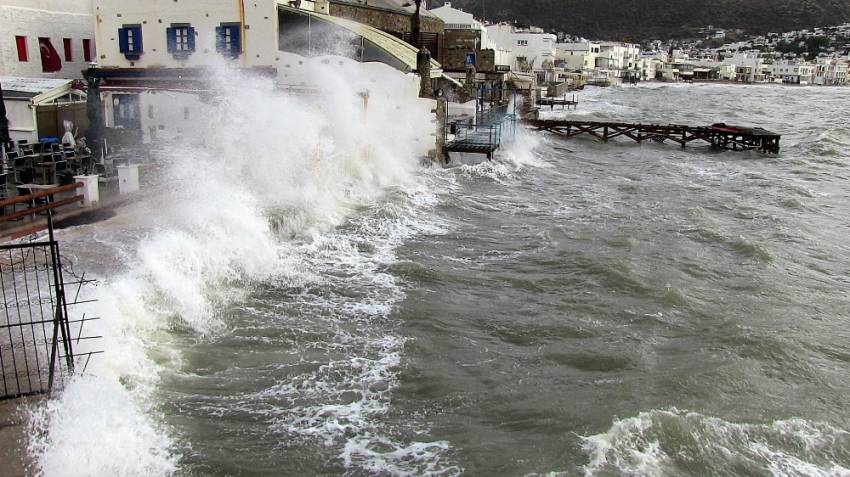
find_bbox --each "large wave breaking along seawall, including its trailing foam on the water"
[29,54,452,476]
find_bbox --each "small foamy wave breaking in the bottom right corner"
[583,408,850,477]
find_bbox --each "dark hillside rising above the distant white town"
[433,0,850,41]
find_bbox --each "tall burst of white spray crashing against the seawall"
[24,57,439,475]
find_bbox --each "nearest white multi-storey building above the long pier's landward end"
[487,23,557,72]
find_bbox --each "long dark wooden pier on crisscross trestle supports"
[525,119,781,154]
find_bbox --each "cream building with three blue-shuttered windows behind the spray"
[87,0,442,142]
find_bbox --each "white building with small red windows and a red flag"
[0,0,95,79]
